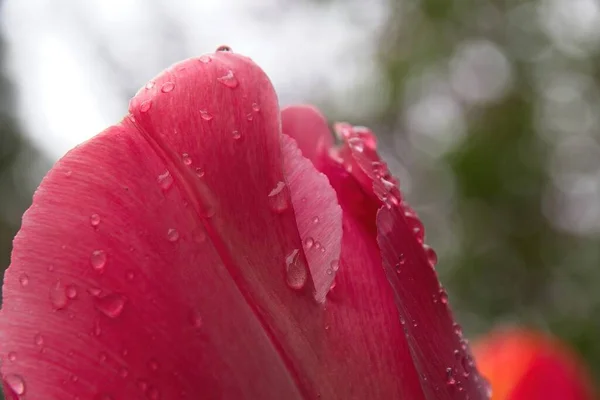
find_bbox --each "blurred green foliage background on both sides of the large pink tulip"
[0,0,600,392]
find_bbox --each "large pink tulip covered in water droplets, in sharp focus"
[0,47,487,400]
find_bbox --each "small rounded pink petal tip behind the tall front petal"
[281,105,333,169]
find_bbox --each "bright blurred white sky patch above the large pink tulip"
[2,0,385,158]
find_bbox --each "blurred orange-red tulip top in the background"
[473,329,596,400]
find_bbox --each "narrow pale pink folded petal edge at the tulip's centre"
[281,135,342,303]
